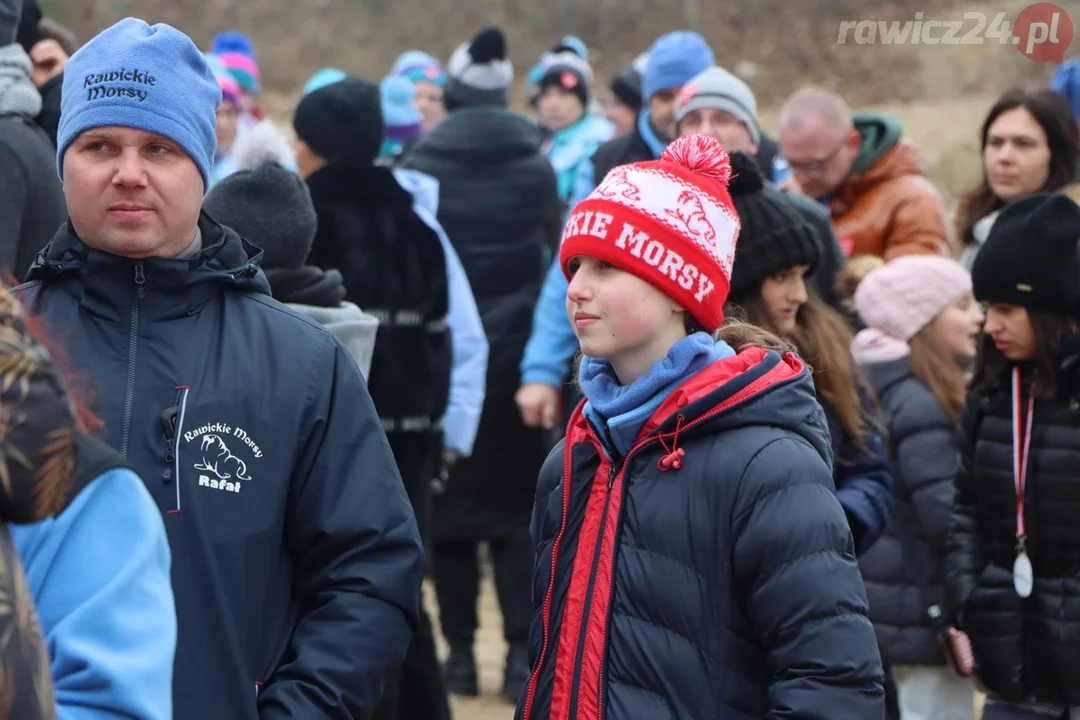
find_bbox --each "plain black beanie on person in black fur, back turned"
[293,77,384,167]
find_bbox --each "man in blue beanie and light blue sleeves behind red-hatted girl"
[516,31,715,429]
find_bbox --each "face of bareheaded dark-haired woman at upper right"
[983,107,1050,203]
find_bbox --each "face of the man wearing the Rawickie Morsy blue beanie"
[64,126,204,259]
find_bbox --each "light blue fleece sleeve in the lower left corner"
[10,468,176,720]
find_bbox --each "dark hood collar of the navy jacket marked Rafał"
[27,213,270,320]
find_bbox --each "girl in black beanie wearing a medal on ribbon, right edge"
[945,194,1080,720]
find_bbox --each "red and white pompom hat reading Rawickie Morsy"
[559,135,739,332]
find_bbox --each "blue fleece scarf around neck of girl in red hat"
[579,332,735,457]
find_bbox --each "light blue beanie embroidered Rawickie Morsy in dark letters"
[56,17,221,188]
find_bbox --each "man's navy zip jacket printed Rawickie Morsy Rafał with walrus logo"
[21,215,422,720]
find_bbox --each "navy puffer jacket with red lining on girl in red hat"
[516,348,885,720]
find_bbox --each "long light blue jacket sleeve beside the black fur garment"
[393,167,488,458]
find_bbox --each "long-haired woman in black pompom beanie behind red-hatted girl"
[730,152,893,554]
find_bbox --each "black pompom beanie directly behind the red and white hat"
[728,152,822,302]
